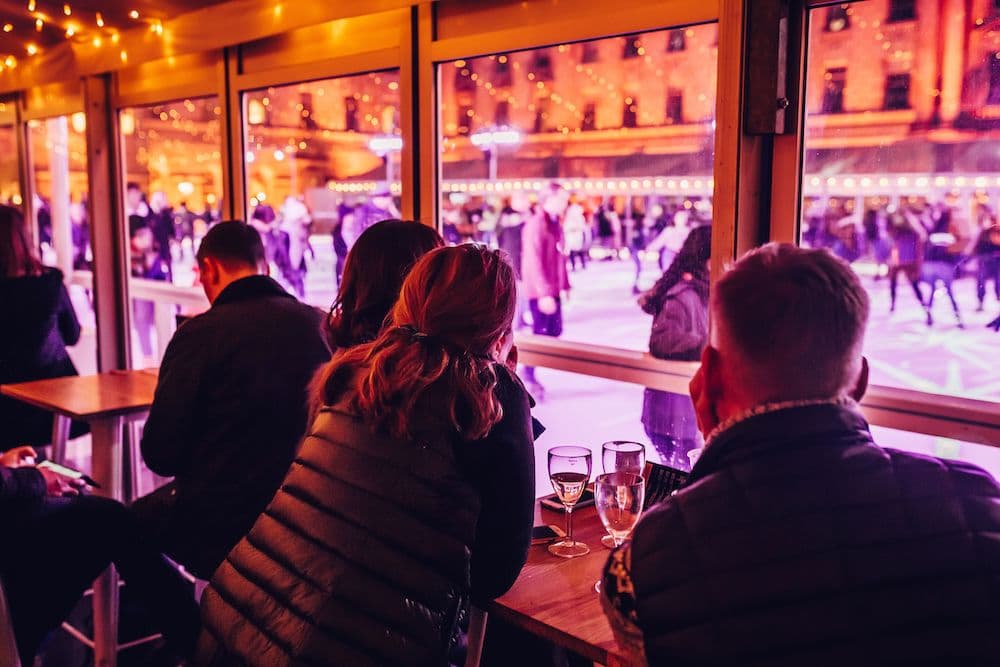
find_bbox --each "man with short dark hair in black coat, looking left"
[133,222,330,579]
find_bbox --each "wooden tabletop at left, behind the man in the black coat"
[0,370,157,421]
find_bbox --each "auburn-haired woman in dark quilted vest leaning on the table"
[199,245,534,667]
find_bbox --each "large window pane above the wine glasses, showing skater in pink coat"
[439,24,717,350]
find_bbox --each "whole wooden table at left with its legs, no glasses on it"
[0,371,156,667]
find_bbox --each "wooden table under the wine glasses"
[486,505,627,667]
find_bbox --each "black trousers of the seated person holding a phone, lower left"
[0,496,200,665]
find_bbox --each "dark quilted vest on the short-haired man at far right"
[630,405,1000,666]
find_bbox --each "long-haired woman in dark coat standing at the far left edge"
[0,206,87,451]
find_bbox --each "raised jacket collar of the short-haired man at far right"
[687,399,874,484]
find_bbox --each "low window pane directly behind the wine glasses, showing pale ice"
[520,368,702,496]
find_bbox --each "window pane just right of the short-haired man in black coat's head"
[243,70,403,307]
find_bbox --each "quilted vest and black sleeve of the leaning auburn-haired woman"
[199,371,534,667]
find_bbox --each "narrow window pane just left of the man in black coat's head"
[118,97,222,368]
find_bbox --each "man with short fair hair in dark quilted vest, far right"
[602,244,1000,666]
